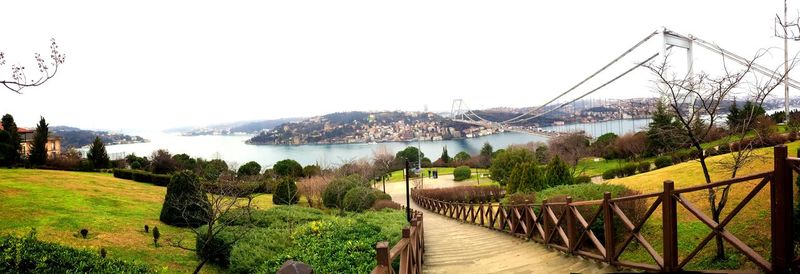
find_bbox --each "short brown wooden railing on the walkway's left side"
[372,209,425,274]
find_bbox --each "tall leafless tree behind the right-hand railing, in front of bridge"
[646,47,786,260]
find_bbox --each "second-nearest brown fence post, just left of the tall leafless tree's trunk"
[661,180,678,272]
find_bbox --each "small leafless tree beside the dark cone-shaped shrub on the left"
[168,173,258,273]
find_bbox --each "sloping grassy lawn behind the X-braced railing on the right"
[608,142,800,270]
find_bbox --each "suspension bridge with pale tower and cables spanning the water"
[450,28,800,137]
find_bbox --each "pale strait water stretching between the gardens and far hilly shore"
[107,119,648,167]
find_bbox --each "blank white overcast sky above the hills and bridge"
[0,0,800,129]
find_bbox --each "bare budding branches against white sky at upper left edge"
[0,38,66,94]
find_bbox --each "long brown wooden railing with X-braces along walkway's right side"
[412,145,800,273]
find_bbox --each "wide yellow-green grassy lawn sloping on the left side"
[0,169,272,273]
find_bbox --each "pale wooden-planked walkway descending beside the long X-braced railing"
[386,175,615,273]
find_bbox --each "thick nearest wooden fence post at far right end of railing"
[769,145,794,273]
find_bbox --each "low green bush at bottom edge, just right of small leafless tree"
[228,228,292,273]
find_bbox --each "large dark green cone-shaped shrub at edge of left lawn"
[160,171,211,227]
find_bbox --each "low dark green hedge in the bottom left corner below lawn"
[0,232,156,273]
